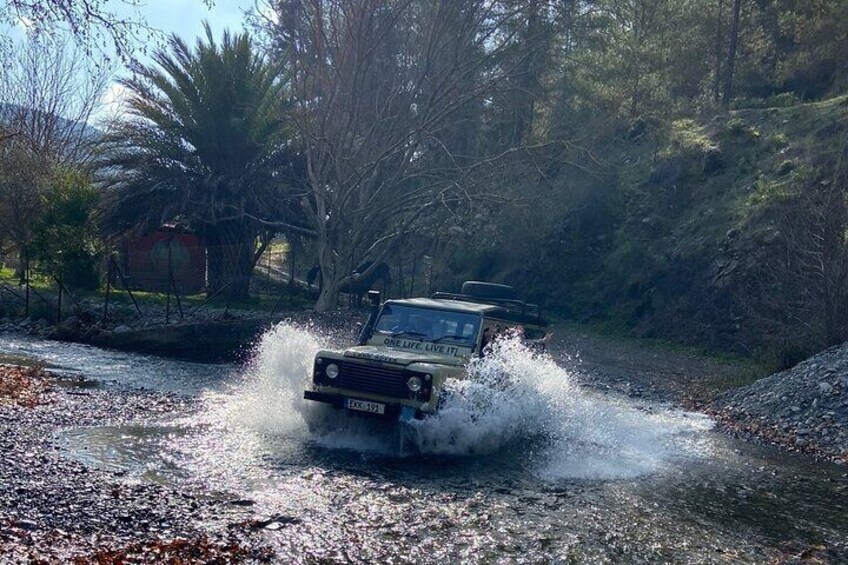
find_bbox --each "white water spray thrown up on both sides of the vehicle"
[209,324,712,480]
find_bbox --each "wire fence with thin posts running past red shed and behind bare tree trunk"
[0,231,464,324]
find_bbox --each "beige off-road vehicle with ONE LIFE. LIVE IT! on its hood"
[303,281,546,420]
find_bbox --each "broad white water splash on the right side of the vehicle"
[408,337,712,480]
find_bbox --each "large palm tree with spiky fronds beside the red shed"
[100,24,298,297]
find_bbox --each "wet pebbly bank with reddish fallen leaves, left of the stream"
[0,367,271,564]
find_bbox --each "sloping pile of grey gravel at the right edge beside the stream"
[708,343,848,464]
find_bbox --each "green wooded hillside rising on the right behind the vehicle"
[380,0,848,363]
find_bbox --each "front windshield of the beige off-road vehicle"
[374,304,480,347]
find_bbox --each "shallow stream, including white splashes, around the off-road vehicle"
[0,324,848,563]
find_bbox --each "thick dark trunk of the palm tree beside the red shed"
[205,221,256,300]
